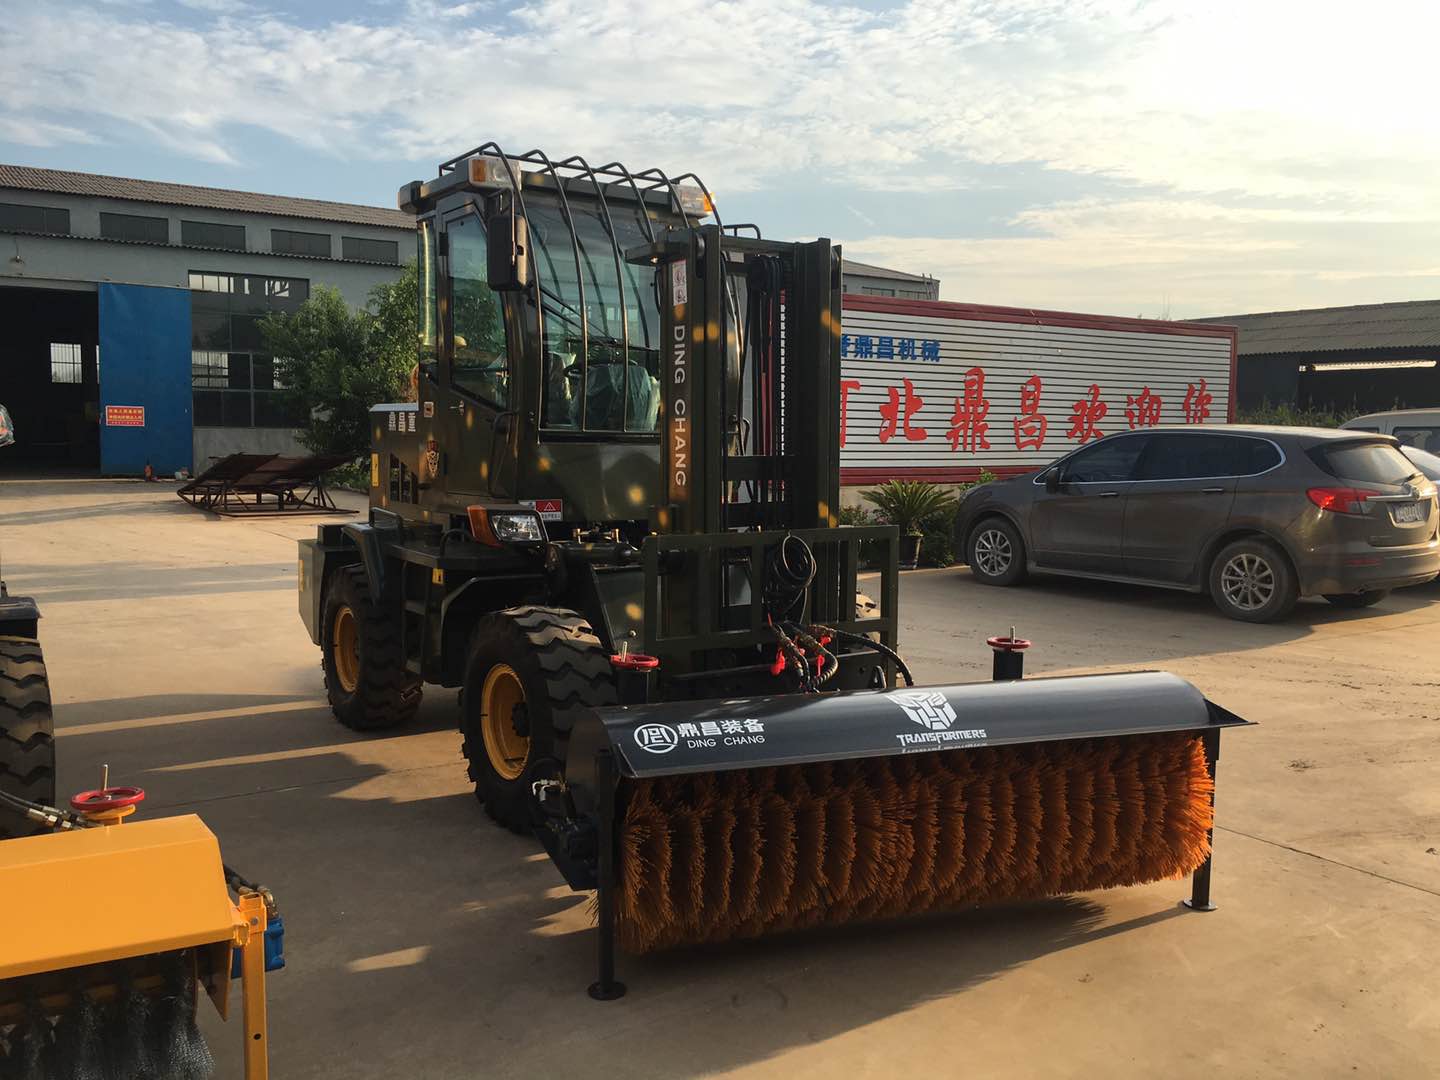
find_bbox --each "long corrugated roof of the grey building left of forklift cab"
[0,164,415,229]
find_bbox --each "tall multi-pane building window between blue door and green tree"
[190,271,310,428]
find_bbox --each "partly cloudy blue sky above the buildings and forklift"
[0,0,1440,317]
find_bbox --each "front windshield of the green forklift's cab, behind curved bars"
[527,200,660,433]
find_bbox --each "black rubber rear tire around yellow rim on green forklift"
[320,566,422,732]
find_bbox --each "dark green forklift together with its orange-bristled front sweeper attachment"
[300,143,1246,998]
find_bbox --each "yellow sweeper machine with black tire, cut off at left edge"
[0,409,284,1080]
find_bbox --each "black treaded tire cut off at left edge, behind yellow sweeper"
[0,636,55,840]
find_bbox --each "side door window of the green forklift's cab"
[446,215,510,408]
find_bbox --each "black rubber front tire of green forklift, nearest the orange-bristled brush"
[459,606,618,834]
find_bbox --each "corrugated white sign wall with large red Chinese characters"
[840,295,1236,484]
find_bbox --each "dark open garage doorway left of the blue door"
[0,285,99,474]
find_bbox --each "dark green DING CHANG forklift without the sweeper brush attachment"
[300,143,907,831]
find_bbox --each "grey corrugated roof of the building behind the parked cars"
[1189,300,1440,356]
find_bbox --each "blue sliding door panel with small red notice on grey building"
[99,285,193,475]
